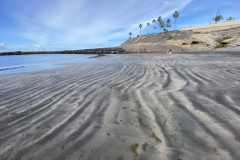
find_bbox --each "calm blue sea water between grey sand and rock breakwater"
[0,54,94,75]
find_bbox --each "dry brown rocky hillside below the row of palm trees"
[121,21,240,52]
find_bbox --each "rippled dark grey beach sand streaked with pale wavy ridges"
[0,53,240,160]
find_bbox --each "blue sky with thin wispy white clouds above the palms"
[0,0,240,52]
